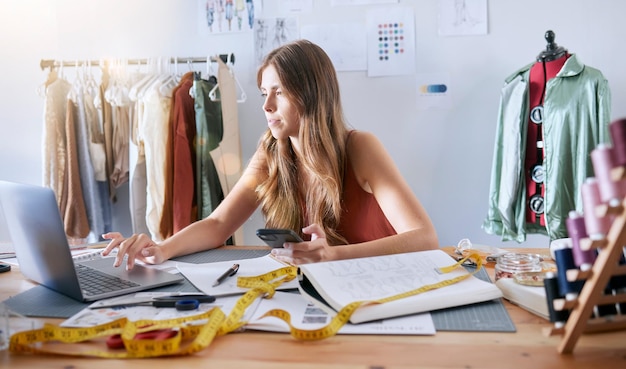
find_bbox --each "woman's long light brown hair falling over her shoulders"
[257,40,348,245]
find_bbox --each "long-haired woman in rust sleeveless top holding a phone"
[103,40,438,269]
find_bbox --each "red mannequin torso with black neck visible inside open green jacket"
[524,31,569,227]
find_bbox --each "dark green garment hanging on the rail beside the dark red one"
[192,73,224,219]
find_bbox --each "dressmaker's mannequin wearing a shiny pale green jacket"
[482,31,611,242]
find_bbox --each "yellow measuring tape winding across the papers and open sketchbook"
[9,254,482,359]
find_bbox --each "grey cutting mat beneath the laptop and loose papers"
[3,249,269,319]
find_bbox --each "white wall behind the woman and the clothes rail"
[0,0,626,247]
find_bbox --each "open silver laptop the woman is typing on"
[0,181,184,301]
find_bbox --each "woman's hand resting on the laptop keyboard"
[102,232,167,270]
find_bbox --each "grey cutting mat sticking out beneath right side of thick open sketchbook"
[430,267,516,332]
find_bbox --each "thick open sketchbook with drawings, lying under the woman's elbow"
[298,250,502,323]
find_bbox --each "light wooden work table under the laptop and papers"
[0,246,626,369]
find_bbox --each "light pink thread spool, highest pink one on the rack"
[591,144,624,207]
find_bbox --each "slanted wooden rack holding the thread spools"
[544,167,626,354]
